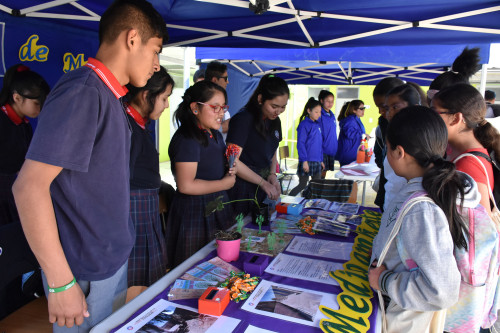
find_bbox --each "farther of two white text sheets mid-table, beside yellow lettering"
[286,236,353,261]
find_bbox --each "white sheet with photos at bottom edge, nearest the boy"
[116,299,240,333]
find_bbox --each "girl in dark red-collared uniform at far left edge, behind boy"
[0,64,50,225]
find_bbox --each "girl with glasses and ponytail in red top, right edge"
[431,83,500,213]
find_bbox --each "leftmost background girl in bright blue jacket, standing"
[289,97,325,196]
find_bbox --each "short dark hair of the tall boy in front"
[99,0,168,44]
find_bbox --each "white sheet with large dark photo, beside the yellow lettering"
[241,279,339,327]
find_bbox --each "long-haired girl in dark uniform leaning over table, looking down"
[226,74,290,214]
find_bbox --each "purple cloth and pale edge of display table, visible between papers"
[91,207,380,333]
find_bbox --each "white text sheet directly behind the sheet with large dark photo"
[265,253,342,286]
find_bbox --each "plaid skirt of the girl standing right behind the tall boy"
[127,189,168,287]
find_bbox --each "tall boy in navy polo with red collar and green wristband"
[13,0,167,332]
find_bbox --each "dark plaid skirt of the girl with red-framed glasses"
[166,191,234,268]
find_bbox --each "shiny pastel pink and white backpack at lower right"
[396,192,500,332]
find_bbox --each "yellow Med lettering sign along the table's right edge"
[319,210,381,333]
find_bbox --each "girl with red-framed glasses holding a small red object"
[167,81,236,266]
